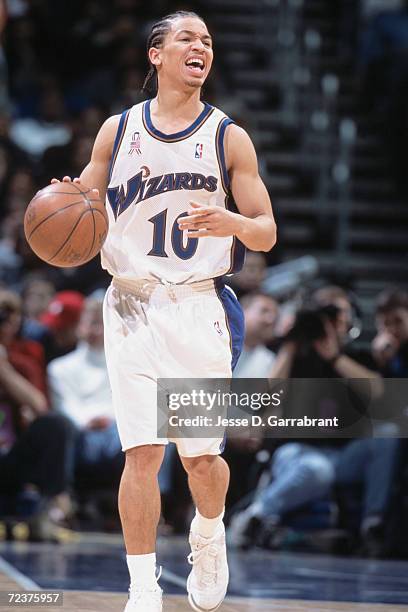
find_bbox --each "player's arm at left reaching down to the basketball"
[51,115,120,200]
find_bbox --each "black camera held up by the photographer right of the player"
[286,304,340,345]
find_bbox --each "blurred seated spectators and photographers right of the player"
[227,272,408,557]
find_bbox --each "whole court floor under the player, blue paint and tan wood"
[0,534,408,612]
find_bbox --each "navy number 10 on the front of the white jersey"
[148,208,198,259]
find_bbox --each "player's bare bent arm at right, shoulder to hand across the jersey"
[179,125,276,251]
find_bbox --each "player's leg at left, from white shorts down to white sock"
[104,287,167,612]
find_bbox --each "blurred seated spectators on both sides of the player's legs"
[0,247,408,556]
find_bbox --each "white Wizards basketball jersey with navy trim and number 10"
[101,100,245,283]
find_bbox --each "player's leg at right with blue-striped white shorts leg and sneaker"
[155,281,243,612]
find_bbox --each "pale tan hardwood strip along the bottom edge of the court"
[0,572,408,612]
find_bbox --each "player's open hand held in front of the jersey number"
[178,202,240,238]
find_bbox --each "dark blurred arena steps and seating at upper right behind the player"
[203,0,408,344]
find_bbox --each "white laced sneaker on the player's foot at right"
[187,525,229,612]
